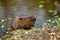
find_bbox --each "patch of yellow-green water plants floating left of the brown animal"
[0,17,12,34]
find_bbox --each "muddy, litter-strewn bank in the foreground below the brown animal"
[1,27,60,40]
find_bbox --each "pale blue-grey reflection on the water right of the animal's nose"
[36,9,46,27]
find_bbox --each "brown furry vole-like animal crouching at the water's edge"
[12,16,36,30]
